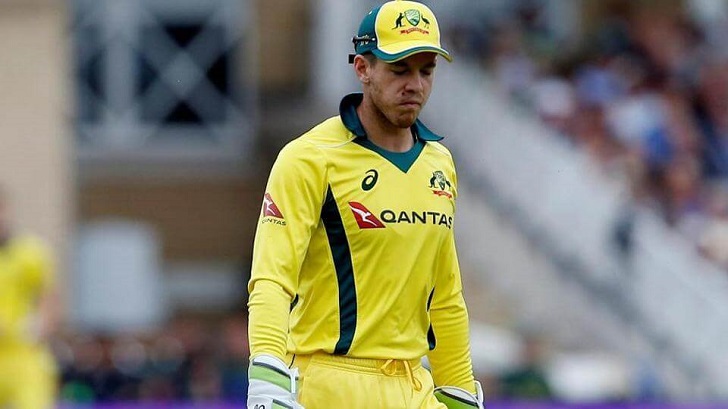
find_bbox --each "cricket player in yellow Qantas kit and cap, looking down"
[248,1,483,409]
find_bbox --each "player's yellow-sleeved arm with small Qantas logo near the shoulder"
[248,140,326,359]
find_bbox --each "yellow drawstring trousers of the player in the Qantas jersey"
[289,353,447,409]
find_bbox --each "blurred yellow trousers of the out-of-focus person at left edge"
[0,344,56,409]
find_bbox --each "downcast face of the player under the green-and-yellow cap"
[364,52,437,128]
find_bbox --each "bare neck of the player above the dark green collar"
[356,98,414,152]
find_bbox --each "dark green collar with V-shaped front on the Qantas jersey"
[339,93,442,173]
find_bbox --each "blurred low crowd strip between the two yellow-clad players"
[52,311,248,405]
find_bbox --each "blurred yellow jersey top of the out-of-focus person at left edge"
[0,236,52,346]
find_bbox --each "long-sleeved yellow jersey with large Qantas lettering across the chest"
[249,94,473,391]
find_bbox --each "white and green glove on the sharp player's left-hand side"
[248,354,304,409]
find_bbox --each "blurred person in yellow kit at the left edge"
[0,187,58,409]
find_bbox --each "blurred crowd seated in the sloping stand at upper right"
[454,1,728,269]
